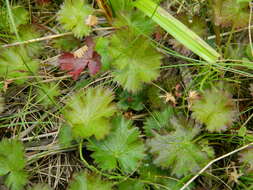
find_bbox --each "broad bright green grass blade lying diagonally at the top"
[134,0,220,63]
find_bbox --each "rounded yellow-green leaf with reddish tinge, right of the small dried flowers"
[192,87,236,132]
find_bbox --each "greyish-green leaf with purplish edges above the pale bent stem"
[147,118,212,177]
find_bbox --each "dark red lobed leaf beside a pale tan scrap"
[58,37,101,80]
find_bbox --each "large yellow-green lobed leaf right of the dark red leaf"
[109,31,162,92]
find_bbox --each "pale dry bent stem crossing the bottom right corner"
[180,142,253,190]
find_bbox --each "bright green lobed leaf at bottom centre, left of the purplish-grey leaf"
[87,117,145,173]
